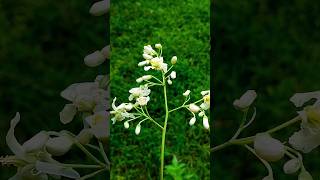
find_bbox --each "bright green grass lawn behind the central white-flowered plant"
[110,0,210,179]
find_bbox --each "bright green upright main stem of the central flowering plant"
[160,73,169,180]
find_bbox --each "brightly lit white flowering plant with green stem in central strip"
[110,44,210,180]
